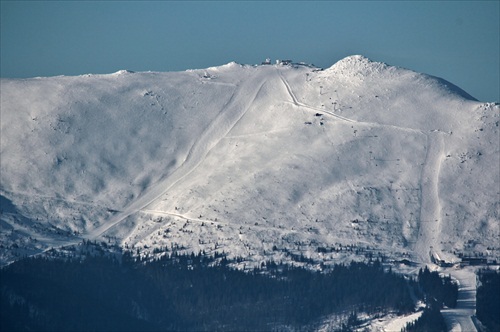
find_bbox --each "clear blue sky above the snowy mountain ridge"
[0,0,500,101]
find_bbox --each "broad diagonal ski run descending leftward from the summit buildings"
[88,72,272,241]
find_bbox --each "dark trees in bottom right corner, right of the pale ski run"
[476,270,500,331]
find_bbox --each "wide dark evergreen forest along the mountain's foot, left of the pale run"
[0,248,458,331]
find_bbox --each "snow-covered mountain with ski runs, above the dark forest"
[0,56,500,264]
